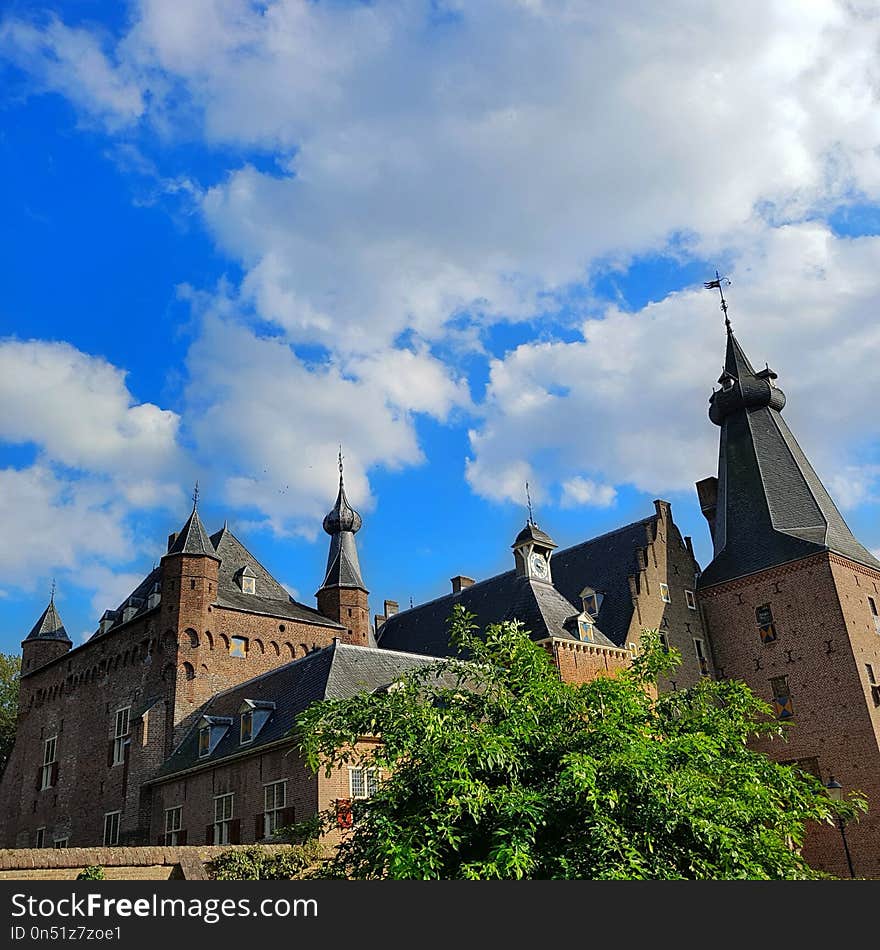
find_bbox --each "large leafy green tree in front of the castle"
[297,609,864,879]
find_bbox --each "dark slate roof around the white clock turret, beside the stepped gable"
[378,516,656,656]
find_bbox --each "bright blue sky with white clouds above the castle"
[0,0,880,652]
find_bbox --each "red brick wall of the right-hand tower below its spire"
[700,553,880,877]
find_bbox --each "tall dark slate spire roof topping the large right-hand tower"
[699,333,880,587]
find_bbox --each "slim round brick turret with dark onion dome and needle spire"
[315,453,370,646]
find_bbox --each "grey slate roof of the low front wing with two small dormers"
[158,642,433,778]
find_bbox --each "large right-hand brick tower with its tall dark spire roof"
[697,318,880,878]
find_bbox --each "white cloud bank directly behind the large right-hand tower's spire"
[468,223,880,507]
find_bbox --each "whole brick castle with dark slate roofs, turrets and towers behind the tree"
[0,324,880,877]
